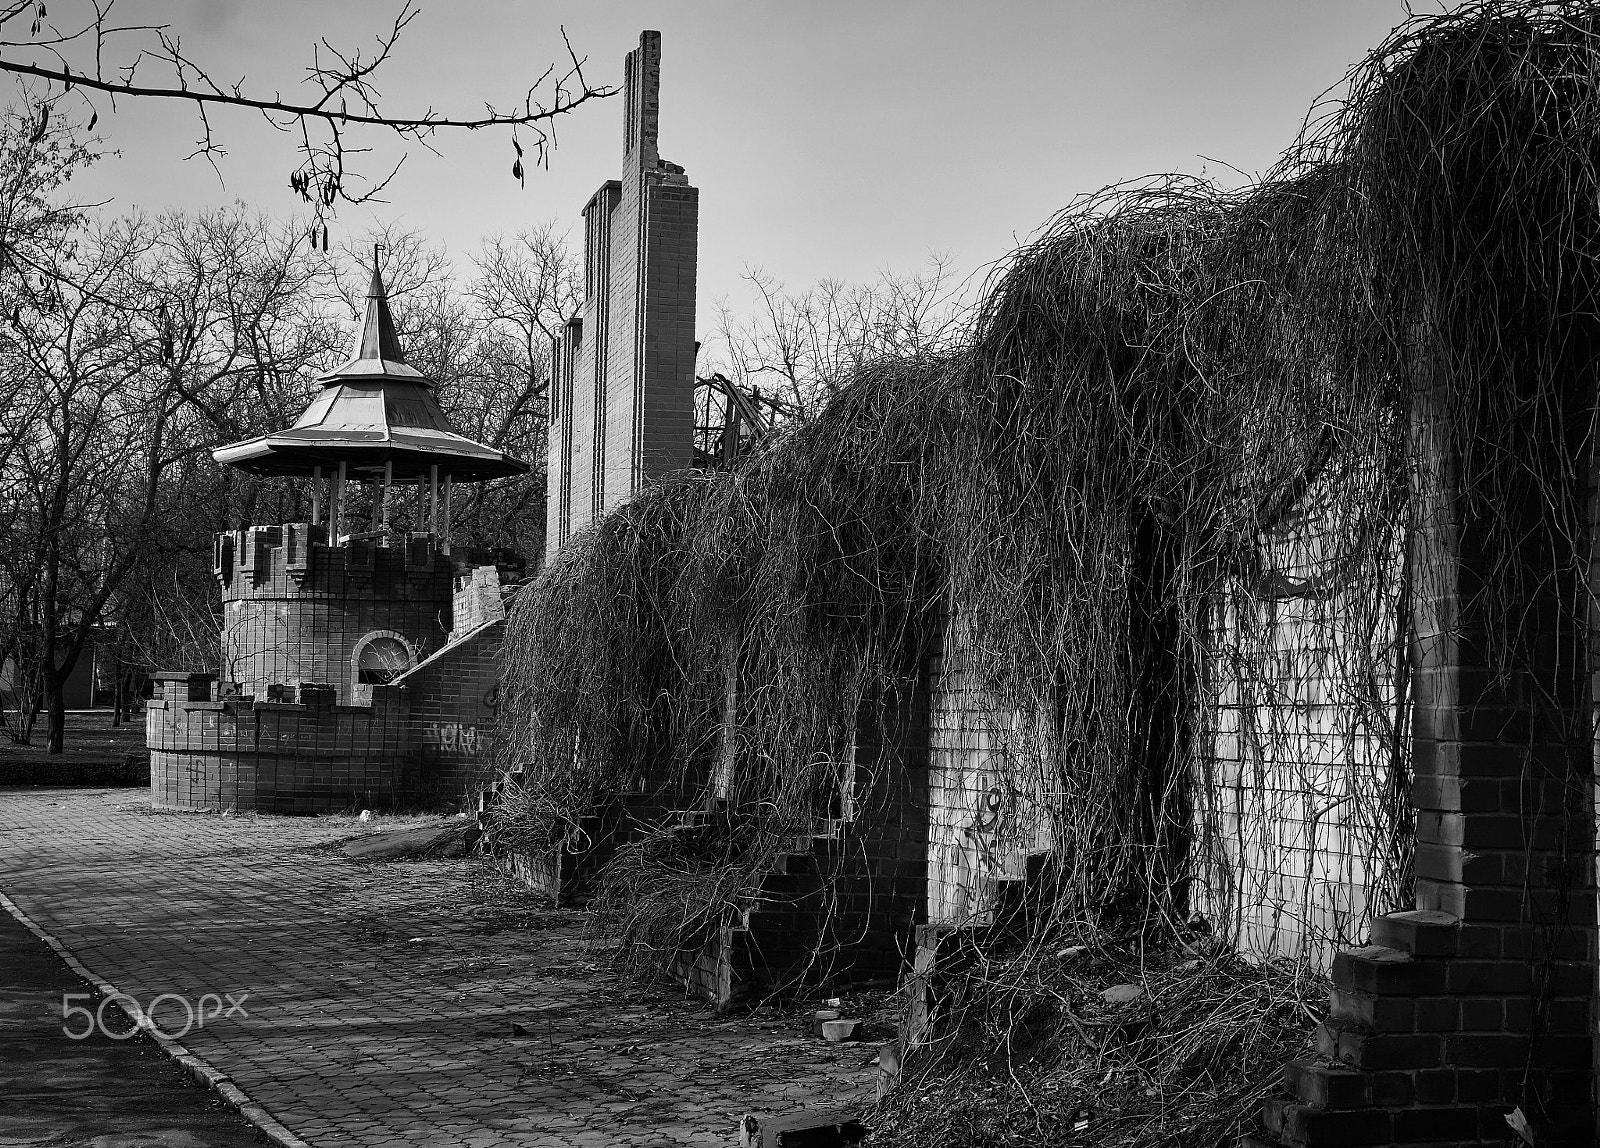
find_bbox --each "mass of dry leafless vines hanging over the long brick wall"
[501,0,1600,1145]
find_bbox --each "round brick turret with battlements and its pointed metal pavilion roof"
[146,267,528,814]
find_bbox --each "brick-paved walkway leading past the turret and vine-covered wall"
[0,790,872,1148]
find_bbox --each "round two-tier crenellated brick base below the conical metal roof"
[146,523,504,812]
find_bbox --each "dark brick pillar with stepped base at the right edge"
[1264,376,1595,1148]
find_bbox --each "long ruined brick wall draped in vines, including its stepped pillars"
[489,13,1600,1148]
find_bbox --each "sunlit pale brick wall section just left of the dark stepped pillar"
[1194,505,1410,969]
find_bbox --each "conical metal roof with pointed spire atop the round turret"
[211,267,530,481]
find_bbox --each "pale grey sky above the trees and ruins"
[37,0,1465,322]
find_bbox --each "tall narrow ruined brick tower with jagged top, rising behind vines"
[546,32,699,560]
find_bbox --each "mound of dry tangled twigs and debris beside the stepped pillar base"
[870,929,1328,1148]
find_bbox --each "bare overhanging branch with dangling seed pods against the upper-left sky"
[0,0,616,214]
